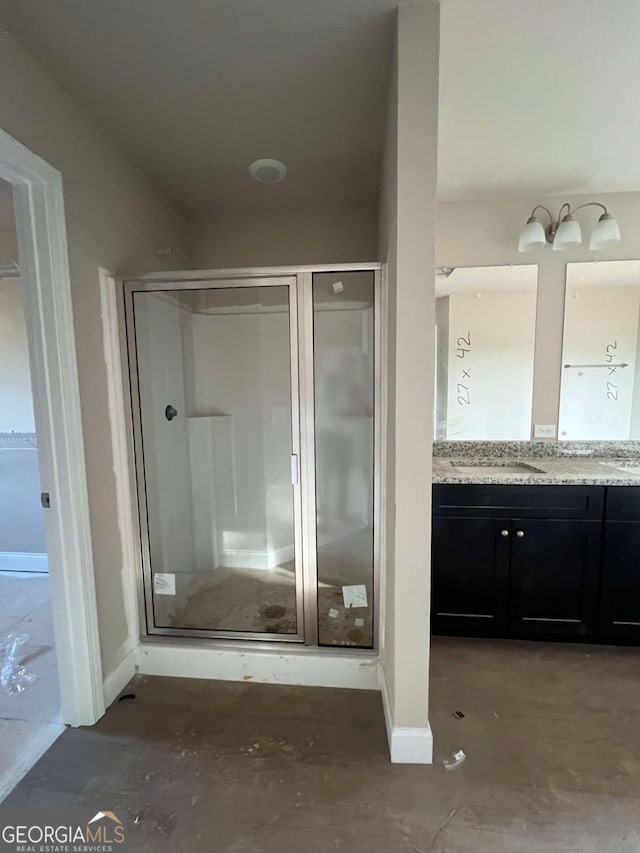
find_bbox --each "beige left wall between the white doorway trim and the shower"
[0,33,189,673]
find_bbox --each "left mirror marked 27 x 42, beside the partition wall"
[434,264,538,441]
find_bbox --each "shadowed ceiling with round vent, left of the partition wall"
[1,0,397,214]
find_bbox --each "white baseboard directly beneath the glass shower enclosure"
[138,641,380,690]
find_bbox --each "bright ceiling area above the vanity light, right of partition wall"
[439,0,640,200]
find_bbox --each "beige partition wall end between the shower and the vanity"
[380,2,439,728]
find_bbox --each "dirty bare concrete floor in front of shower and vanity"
[4,638,640,853]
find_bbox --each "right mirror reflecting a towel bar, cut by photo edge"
[558,261,640,441]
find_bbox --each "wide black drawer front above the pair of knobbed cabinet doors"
[433,483,604,520]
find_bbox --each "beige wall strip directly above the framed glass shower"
[192,208,378,269]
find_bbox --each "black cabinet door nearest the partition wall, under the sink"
[431,517,510,636]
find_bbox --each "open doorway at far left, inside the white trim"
[0,175,64,799]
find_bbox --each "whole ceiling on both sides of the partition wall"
[1,0,640,215]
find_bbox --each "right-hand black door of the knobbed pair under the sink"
[509,519,601,638]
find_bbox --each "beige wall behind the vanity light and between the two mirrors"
[436,193,640,432]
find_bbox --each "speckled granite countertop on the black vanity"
[433,441,640,486]
